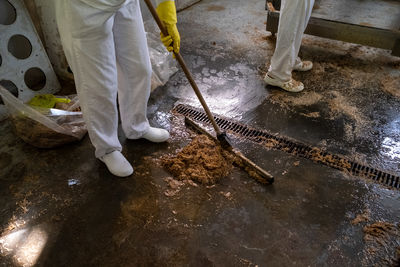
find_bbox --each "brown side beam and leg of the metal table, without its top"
[265,0,400,57]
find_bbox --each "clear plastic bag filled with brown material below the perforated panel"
[0,86,87,148]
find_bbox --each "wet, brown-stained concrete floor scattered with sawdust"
[0,0,400,266]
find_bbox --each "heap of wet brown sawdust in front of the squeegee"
[162,135,234,184]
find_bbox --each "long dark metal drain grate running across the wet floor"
[172,104,400,188]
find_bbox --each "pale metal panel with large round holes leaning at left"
[0,0,60,120]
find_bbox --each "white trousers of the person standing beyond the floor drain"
[268,0,314,81]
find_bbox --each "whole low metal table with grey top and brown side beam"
[266,0,400,57]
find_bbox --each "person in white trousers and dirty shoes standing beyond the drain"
[264,0,314,92]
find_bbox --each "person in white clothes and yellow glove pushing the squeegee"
[55,0,180,177]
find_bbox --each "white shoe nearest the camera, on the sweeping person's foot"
[100,151,133,177]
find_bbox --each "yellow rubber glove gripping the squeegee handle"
[156,0,181,53]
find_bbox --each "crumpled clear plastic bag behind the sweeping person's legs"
[145,20,178,91]
